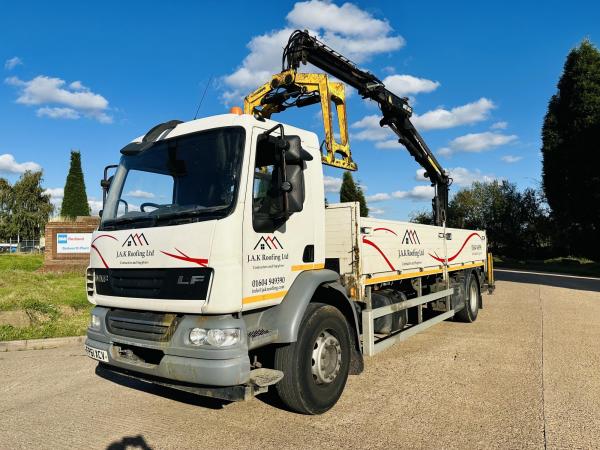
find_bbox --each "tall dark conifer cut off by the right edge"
[542,39,600,257]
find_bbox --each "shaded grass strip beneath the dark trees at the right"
[494,256,600,277]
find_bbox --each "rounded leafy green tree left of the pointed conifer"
[9,171,54,239]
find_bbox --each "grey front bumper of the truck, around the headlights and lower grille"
[86,307,250,386]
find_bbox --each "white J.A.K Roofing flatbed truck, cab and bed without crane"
[85,29,493,414]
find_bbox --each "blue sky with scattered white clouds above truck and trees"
[0,0,600,220]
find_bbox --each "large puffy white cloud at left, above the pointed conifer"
[4,75,112,123]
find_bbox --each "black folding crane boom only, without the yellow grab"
[282,30,451,225]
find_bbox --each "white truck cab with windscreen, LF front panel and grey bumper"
[86,114,338,396]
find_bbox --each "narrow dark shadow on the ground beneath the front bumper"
[96,367,231,412]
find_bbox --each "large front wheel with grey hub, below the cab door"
[274,303,352,414]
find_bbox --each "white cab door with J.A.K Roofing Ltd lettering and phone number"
[242,127,320,310]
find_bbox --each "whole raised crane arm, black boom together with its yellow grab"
[244,30,452,226]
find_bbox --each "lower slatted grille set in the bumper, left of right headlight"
[106,309,178,342]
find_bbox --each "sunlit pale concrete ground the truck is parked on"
[0,272,600,450]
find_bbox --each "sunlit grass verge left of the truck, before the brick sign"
[0,255,92,341]
